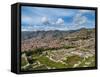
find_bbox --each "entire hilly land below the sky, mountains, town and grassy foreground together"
[21,28,95,70]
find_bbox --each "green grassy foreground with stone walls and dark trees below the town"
[21,46,95,70]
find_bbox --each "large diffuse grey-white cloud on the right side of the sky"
[69,10,89,29]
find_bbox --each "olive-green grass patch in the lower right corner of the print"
[64,55,95,68]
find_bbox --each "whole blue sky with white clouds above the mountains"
[21,6,95,31]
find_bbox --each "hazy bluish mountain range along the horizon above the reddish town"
[22,28,95,40]
